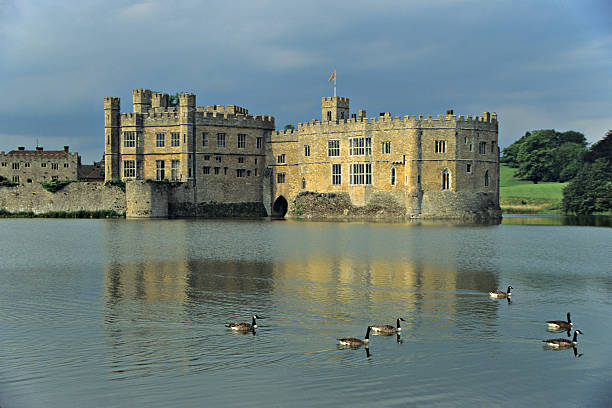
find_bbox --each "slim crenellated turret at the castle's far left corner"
[104,96,121,181]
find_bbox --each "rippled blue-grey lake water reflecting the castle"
[0,217,612,408]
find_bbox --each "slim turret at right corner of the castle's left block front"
[179,93,196,182]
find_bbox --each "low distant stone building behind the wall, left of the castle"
[0,146,81,184]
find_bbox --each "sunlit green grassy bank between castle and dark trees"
[499,166,567,214]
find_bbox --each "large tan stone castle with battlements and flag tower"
[104,89,501,218]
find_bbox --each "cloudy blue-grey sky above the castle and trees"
[0,0,612,163]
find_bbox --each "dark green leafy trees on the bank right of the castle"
[500,129,612,214]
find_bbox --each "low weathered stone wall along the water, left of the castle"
[0,182,126,214]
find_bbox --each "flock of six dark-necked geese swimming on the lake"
[225,286,582,354]
